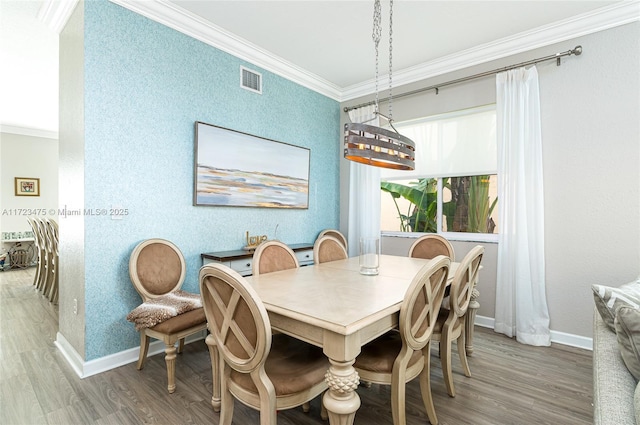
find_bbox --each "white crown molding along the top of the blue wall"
[110,0,341,101]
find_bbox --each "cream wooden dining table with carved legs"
[212,255,458,425]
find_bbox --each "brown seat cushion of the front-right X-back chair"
[353,331,422,374]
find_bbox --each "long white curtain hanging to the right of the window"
[495,66,551,346]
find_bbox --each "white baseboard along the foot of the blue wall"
[55,331,206,378]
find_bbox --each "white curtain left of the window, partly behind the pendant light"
[347,105,380,257]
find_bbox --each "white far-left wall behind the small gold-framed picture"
[0,132,58,232]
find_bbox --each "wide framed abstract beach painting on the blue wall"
[193,121,310,209]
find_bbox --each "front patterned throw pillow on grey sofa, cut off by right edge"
[614,306,640,380]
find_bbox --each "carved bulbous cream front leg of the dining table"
[322,359,360,425]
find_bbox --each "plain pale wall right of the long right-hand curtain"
[540,22,640,336]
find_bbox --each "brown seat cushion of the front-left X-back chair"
[230,334,329,397]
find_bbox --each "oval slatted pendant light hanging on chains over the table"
[344,0,416,170]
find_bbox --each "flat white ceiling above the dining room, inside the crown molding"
[172,0,615,88]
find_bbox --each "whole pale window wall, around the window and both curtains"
[341,22,640,342]
